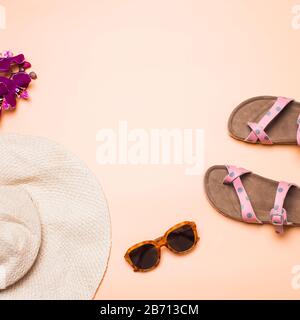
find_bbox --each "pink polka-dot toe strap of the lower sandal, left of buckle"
[223,165,262,224]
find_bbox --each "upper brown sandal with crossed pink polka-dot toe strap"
[228,96,300,145]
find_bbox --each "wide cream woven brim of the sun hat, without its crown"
[0,134,111,300]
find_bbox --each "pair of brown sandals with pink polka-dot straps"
[204,96,300,234]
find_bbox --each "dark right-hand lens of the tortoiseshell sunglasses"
[167,225,196,252]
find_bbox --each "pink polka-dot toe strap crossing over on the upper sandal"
[245,97,292,144]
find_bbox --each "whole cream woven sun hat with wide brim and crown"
[0,134,111,299]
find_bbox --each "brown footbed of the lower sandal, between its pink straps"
[204,166,300,226]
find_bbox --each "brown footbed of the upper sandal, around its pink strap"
[228,96,300,144]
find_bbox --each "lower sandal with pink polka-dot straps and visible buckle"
[204,166,300,234]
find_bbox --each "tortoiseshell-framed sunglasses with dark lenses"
[125,221,199,272]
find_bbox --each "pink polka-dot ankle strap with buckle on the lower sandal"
[270,181,292,234]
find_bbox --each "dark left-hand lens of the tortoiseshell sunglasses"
[129,244,159,270]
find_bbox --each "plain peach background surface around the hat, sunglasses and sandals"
[0,0,300,299]
